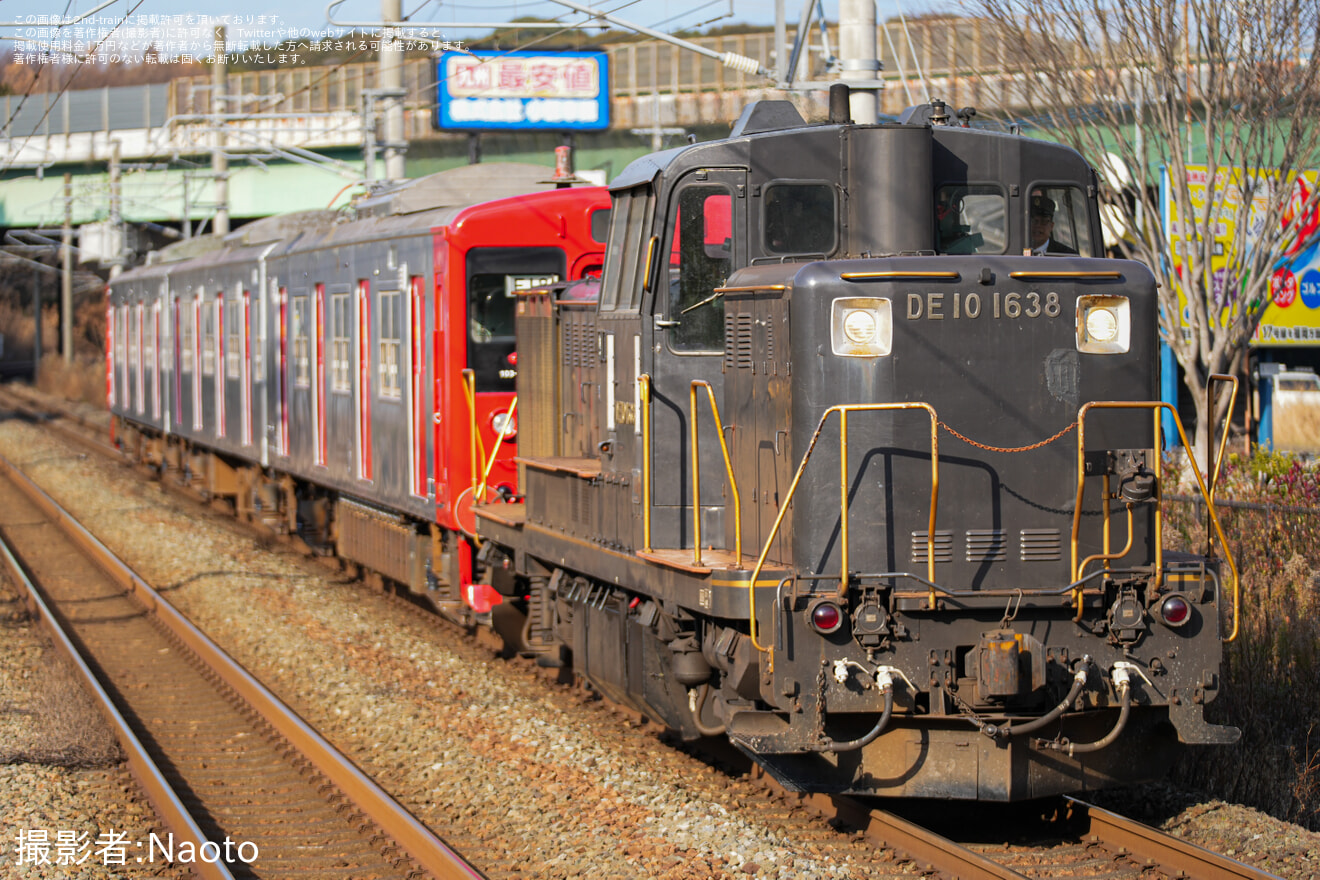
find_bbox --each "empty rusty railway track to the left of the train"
[0,448,482,877]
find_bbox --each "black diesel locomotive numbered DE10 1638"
[475,93,1238,801]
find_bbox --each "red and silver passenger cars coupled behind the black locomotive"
[107,164,609,613]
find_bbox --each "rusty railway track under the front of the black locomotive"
[0,387,1298,880]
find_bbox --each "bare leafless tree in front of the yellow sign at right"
[970,0,1320,463]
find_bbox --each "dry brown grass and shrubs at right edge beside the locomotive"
[1166,453,1320,829]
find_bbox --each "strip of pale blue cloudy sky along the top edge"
[0,0,813,55]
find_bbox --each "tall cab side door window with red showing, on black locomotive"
[661,183,733,351]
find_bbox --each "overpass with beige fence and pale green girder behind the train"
[0,17,1030,241]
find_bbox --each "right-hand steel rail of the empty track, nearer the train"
[0,455,484,880]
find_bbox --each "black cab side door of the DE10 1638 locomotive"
[643,169,747,548]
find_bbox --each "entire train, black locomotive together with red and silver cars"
[107,87,1238,801]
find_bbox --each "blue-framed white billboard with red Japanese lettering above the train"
[436,51,610,132]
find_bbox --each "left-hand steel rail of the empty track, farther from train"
[0,538,234,880]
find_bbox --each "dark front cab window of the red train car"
[467,248,568,391]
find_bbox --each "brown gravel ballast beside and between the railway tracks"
[0,403,1320,879]
